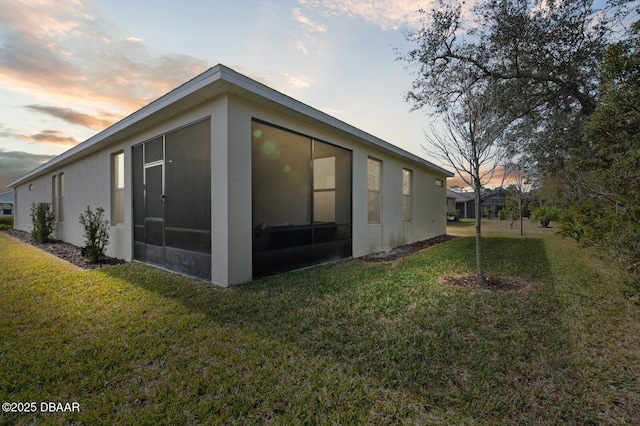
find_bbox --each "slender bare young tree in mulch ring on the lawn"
[425,90,506,286]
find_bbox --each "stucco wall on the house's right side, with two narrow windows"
[228,96,446,272]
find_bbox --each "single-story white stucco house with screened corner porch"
[9,65,453,286]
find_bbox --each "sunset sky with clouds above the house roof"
[0,0,470,192]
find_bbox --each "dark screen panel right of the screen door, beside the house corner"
[165,119,211,278]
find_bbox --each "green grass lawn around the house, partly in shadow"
[0,220,640,425]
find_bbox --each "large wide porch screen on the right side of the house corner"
[251,121,352,278]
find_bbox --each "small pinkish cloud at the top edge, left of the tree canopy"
[298,0,431,31]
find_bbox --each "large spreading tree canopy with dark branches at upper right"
[402,0,634,169]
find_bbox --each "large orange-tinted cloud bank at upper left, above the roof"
[0,0,208,116]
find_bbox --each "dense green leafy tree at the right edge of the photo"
[562,21,640,273]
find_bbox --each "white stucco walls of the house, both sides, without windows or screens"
[15,94,446,286]
